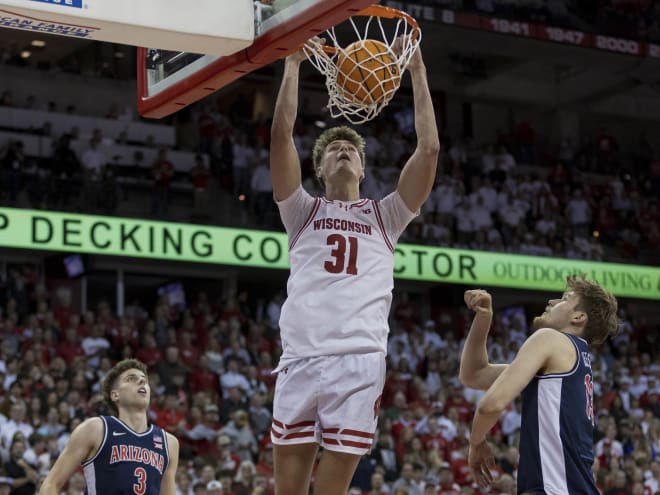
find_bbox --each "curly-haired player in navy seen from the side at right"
[460,277,618,495]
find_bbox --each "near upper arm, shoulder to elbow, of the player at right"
[479,328,565,414]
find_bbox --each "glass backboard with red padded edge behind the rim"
[135,0,374,118]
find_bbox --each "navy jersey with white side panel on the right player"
[518,334,599,495]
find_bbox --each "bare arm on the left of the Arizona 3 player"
[39,418,104,495]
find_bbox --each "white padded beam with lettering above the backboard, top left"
[0,0,254,56]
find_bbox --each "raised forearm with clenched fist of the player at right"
[458,289,507,390]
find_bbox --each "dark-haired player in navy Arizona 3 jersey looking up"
[39,359,179,495]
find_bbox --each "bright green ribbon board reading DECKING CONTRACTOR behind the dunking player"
[0,208,660,300]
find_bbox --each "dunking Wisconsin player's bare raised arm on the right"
[397,42,440,211]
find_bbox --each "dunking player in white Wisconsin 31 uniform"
[270,37,440,495]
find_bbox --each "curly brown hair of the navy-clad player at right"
[566,275,619,344]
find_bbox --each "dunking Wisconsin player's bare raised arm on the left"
[270,44,305,201]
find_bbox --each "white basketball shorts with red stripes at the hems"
[271,352,385,455]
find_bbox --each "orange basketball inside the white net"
[337,40,401,105]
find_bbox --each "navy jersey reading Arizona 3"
[83,416,170,495]
